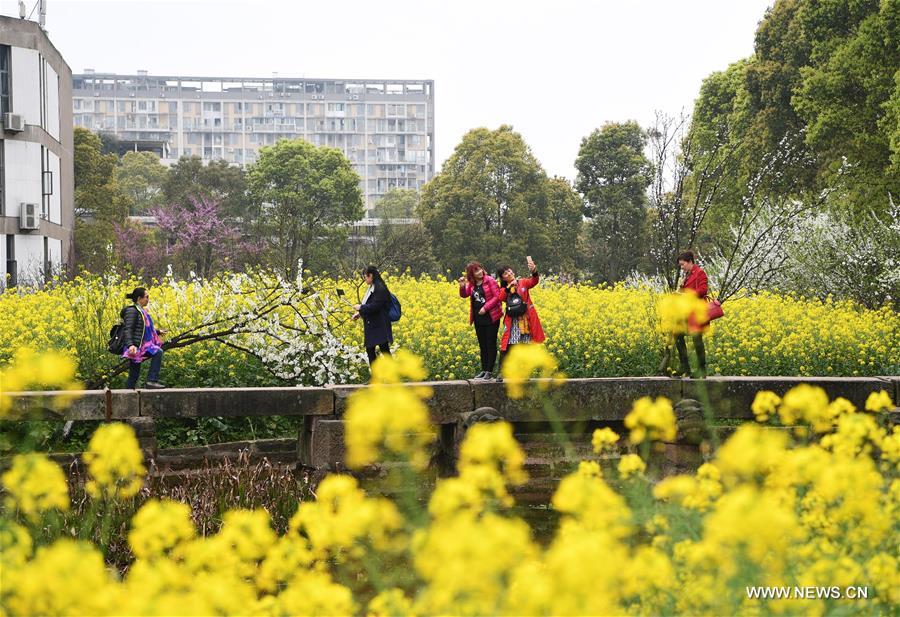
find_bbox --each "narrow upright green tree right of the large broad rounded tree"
[575,121,651,283]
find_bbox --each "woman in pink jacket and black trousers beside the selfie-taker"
[459,261,503,379]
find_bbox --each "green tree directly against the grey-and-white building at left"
[73,127,128,272]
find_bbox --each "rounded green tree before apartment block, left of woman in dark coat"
[248,139,363,277]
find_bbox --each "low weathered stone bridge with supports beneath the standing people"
[9,376,900,490]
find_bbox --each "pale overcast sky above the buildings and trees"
[0,0,771,179]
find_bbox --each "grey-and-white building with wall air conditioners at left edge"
[0,15,75,286]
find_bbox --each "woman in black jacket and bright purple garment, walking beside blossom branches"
[119,287,165,390]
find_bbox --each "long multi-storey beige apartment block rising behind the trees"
[72,69,434,209]
